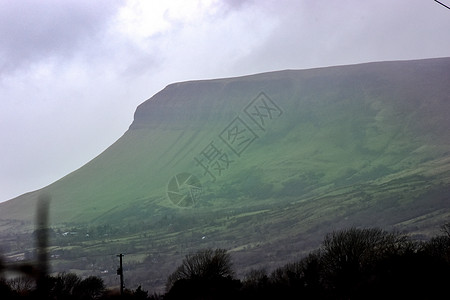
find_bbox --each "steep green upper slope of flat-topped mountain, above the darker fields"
[0,59,450,222]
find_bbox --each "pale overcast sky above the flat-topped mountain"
[0,0,450,202]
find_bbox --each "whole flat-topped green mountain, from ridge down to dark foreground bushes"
[0,58,450,285]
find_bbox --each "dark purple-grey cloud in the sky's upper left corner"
[0,0,121,75]
